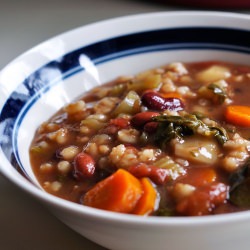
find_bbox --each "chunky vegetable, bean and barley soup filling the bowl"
[30,61,250,216]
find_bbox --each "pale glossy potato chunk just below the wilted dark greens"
[174,136,220,164]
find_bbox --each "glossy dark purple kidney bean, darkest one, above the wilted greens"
[141,91,184,111]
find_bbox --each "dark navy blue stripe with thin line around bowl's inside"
[0,27,250,176]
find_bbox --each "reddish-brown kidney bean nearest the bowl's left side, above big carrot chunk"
[73,152,96,179]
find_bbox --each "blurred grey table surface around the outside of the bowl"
[0,0,250,250]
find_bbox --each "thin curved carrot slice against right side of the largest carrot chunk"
[132,177,158,215]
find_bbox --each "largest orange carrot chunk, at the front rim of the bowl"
[83,169,143,213]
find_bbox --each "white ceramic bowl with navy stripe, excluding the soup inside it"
[0,12,250,250]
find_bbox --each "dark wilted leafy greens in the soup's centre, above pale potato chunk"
[152,115,228,148]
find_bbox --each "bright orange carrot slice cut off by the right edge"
[225,105,250,127]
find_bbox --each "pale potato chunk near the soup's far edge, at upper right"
[196,65,231,82]
